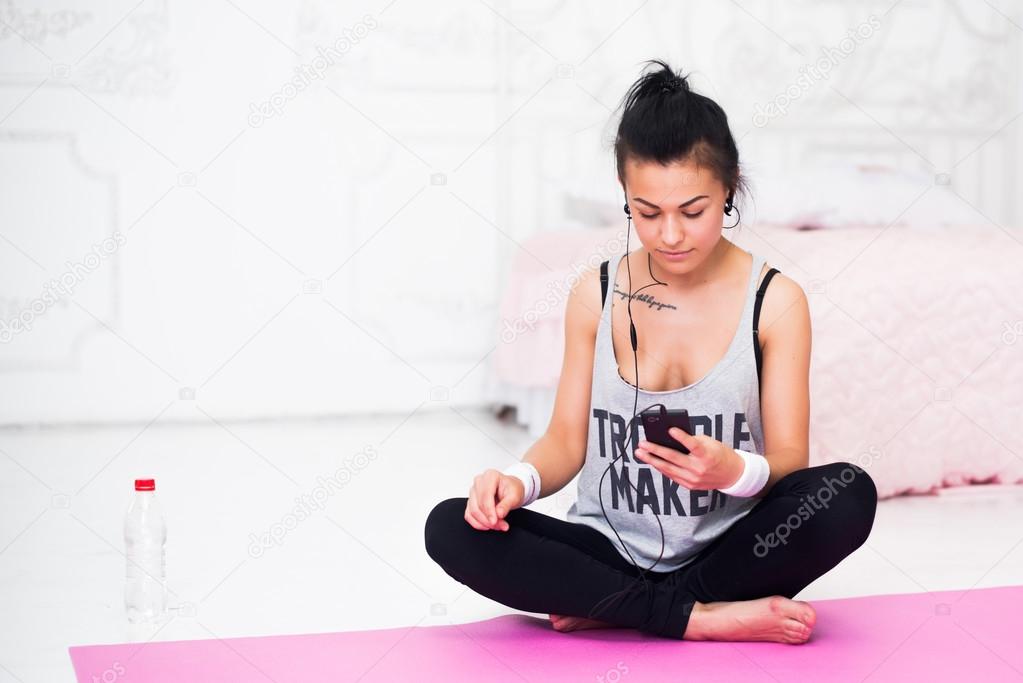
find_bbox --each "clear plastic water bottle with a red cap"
[125,480,167,623]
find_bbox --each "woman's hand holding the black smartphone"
[635,427,745,491]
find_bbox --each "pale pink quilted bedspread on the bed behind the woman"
[495,224,1023,497]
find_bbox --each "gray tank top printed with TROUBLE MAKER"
[567,247,776,572]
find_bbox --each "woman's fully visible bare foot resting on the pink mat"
[682,595,816,644]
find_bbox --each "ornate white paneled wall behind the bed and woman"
[0,0,1023,423]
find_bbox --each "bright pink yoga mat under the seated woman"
[70,586,1023,683]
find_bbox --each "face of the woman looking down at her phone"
[625,158,727,274]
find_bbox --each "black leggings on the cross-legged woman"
[425,462,878,639]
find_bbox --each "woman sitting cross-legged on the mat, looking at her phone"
[425,60,877,643]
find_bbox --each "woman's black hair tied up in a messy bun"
[615,59,748,208]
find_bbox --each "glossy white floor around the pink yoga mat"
[0,410,1023,683]
